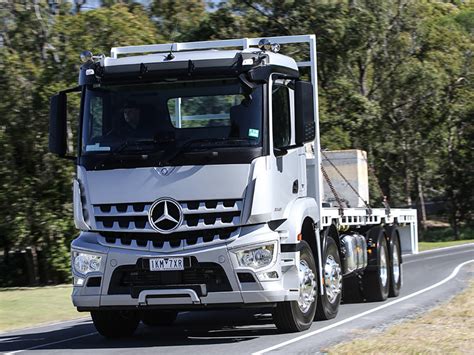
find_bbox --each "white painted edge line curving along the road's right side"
[253,259,474,355]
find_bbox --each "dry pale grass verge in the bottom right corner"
[322,282,474,354]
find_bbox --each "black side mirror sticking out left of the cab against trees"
[49,92,67,157]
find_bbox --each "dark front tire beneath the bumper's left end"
[91,311,140,338]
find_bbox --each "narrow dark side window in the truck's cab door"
[272,85,291,148]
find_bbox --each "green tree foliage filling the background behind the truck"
[0,0,474,283]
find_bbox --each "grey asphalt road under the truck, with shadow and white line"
[0,244,474,354]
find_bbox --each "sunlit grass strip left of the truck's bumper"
[0,285,84,331]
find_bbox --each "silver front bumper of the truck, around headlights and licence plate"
[72,225,299,311]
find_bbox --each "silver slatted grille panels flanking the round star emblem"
[93,199,243,233]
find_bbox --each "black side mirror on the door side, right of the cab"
[295,81,316,145]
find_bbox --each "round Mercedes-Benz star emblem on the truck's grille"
[148,198,183,234]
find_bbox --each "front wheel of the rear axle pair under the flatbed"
[363,227,390,301]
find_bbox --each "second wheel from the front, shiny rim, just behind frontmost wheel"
[316,237,342,320]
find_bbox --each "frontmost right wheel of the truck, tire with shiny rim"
[272,241,318,333]
